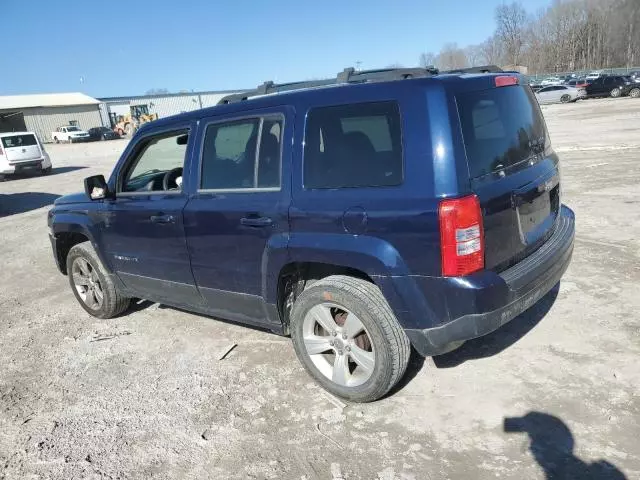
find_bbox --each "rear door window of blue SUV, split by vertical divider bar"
[200,117,283,190]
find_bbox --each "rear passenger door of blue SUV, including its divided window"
[184,109,293,322]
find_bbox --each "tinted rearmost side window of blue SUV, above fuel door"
[304,102,403,188]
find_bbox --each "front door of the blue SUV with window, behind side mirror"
[101,126,202,306]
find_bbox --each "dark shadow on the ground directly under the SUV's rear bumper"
[433,283,560,368]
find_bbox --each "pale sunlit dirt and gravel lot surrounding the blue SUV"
[0,98,640,480]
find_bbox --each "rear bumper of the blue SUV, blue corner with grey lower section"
[405,206,575,356]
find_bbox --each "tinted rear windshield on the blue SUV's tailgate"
[456,86,547,178]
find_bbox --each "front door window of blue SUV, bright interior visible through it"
[121,130,189,193]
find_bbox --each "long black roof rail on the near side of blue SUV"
[218,67,438,105]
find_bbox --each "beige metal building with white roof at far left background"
[0,92,102,142]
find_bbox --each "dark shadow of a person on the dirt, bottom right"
[504,412,627,480]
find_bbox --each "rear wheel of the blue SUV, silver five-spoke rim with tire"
[291,275,411,402]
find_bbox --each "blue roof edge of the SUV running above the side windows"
[138,72,524,131]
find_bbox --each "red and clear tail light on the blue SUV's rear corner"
[438,195,484,277]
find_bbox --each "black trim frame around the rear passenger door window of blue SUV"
[196,112,286,193]
